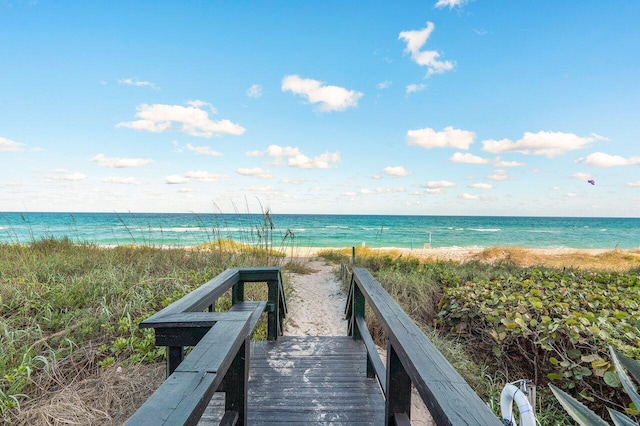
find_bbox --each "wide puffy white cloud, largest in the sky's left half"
[116,100,245,138]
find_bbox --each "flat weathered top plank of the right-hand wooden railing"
[353,268,501,426]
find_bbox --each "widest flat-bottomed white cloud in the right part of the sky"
[482,132,606,158]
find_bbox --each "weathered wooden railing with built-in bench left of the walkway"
[127,268,287,426]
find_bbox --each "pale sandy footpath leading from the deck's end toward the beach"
[284,257,435,426]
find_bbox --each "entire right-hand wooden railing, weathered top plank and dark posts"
[342,264,502,426]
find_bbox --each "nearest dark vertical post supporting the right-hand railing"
[384,341,411,425]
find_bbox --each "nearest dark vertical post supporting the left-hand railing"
[222,339,251,426]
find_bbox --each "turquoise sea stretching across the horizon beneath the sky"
[0,213,640,249]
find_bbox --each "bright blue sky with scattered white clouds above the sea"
[0,0,640,217]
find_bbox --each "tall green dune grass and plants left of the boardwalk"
[0,239,300,422]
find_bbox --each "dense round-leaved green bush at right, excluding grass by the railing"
[439,268,640,414]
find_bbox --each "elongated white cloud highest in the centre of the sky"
[282,75,363,111]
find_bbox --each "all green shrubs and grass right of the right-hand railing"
[336,251,640,424]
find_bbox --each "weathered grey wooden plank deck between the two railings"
[199,336,384,426]
